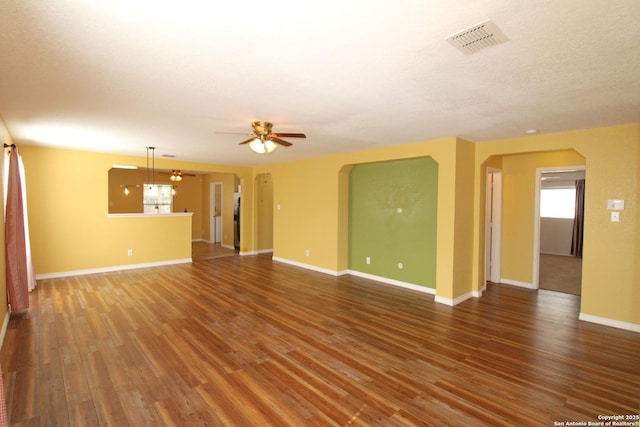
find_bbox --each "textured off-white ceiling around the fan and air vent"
[0,0,640,165]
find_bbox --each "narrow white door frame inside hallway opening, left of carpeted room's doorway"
[484,167,502,286]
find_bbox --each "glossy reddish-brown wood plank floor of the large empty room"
[0,256,640,426]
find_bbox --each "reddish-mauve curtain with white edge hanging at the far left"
[4,145,36,313]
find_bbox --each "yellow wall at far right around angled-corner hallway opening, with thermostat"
[474,124,640,325]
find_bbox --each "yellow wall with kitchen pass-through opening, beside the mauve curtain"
[19,145,252,275]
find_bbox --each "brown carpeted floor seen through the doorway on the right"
[540,254,582,295]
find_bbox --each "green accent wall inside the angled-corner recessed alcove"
[349,157,438,289]
